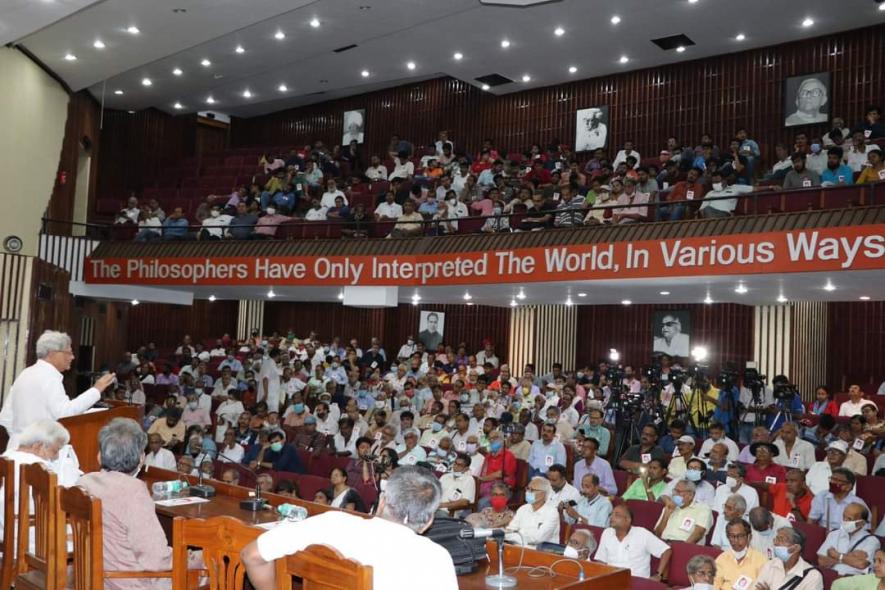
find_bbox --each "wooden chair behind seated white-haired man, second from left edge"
[15,463,67,590]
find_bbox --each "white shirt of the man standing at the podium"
[0,359,101,449]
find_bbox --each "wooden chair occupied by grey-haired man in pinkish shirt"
[58,487,178,590]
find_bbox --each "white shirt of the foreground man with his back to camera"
[258,511,458,590]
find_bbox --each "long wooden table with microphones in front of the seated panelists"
[140,468,630,590]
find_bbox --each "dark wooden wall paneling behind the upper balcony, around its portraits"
[231,25,885,170]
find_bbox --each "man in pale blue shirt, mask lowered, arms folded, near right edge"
[817,503,880,576]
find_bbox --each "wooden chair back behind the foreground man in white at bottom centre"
[276,545,373,590]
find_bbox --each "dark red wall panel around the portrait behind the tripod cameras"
[577,303,753,368]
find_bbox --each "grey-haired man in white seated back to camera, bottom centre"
[241,466,458,590]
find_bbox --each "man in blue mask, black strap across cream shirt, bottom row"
[755,526,824,590]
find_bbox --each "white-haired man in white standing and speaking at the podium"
[0,330,115,449]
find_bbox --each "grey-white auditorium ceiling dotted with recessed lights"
[8,0,885,116]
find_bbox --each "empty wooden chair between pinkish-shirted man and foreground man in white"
[172,516,264,590]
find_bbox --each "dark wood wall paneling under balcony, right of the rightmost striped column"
[827,301,885,394]
